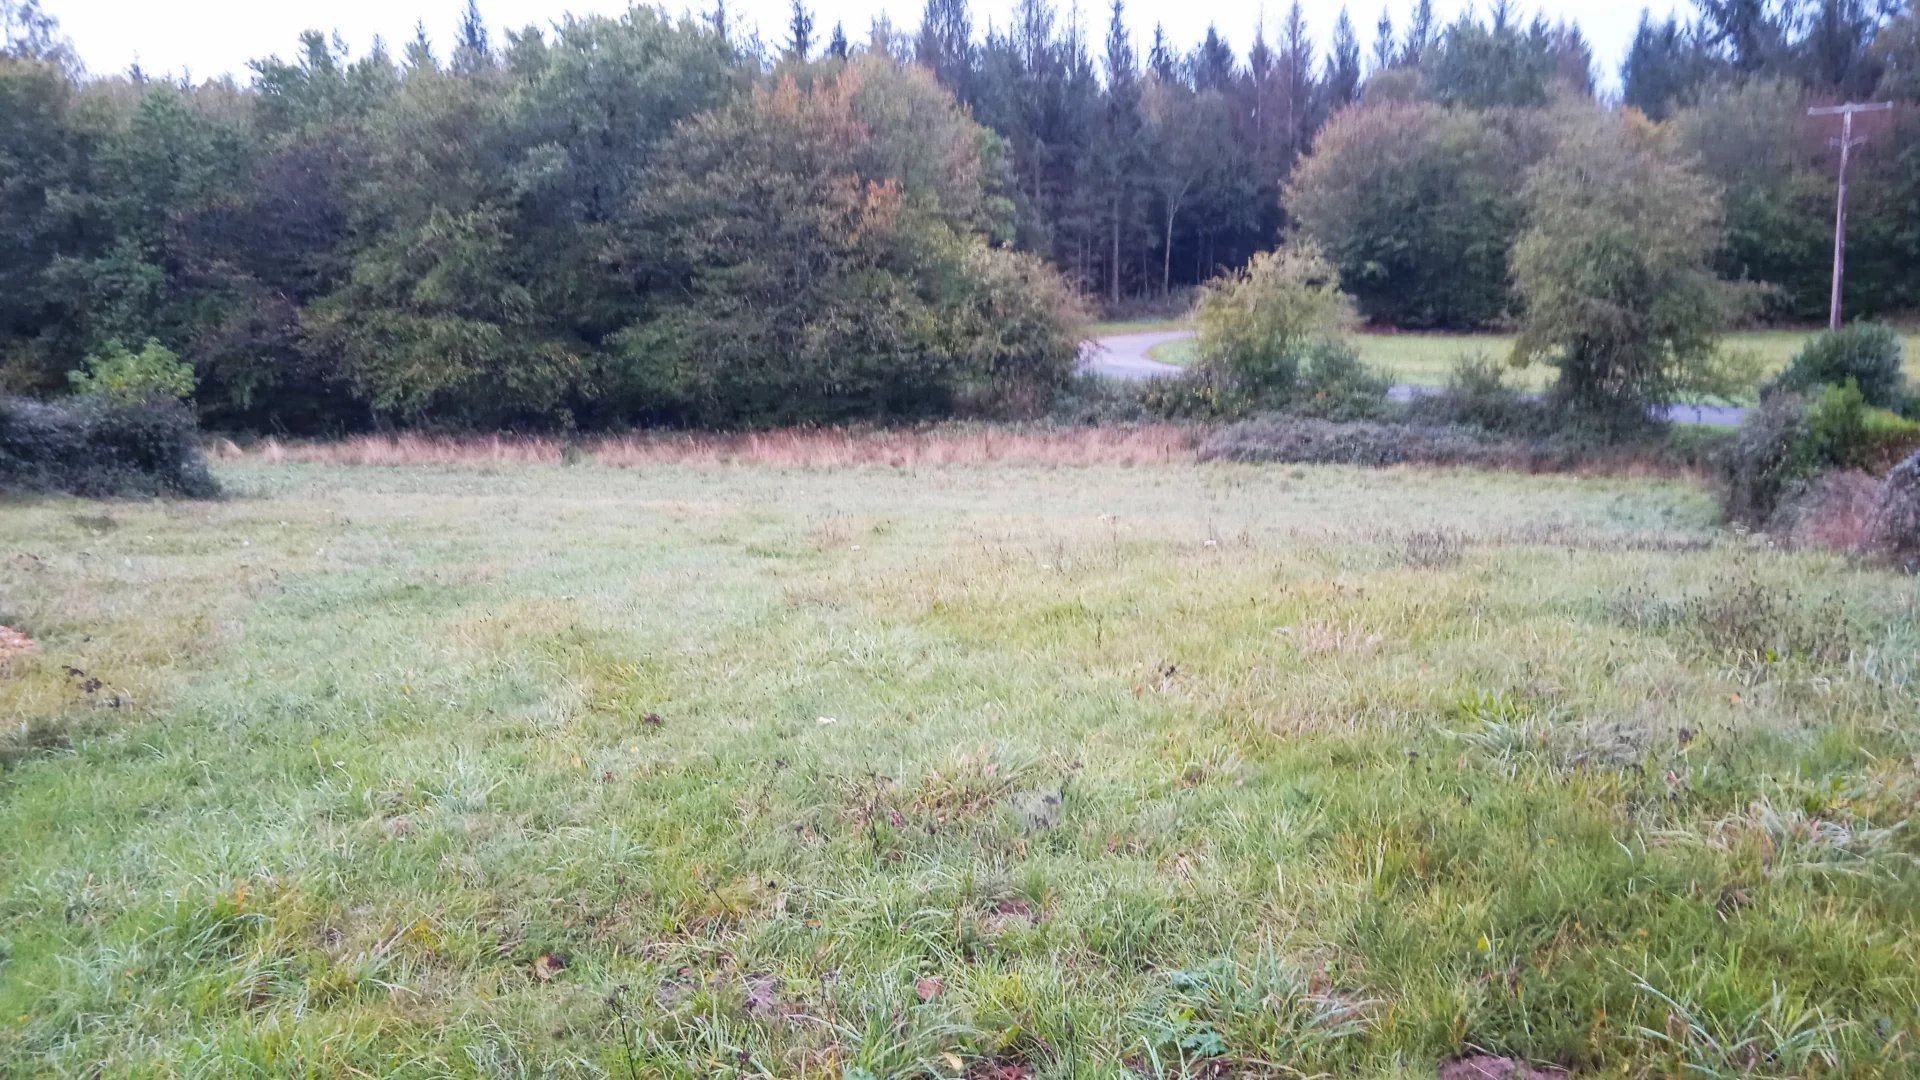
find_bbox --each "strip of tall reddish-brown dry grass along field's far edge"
[211,425,1196,469]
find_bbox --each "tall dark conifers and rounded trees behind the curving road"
[917,0,1920,329]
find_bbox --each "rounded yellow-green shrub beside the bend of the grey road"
[1194,242,1354,404]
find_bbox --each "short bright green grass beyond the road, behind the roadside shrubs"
[1102,321,1920,401]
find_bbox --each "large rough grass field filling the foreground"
[0,448,1920,1080]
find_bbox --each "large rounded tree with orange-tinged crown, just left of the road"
[614,58,1083,427]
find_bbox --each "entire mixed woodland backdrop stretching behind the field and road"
[0,0,1920,430]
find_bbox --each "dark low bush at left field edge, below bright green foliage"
[0,396,219,498]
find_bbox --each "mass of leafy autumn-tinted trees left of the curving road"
[0,0,1081,430]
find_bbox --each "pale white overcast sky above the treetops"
[44,0,1676,85]
